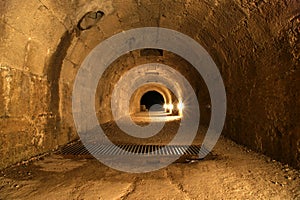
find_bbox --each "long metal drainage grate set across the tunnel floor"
[60,143,209,156]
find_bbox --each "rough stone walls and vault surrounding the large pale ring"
[0,0,300,169]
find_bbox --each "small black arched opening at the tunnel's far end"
[140,91,165,112]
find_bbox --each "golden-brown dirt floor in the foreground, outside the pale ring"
[0,116,300,200]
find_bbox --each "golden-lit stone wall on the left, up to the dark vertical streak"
[0,1,74,168]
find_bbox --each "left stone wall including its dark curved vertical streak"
[0,0,116,168]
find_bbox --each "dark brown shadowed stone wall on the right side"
[219,1,300,167]
